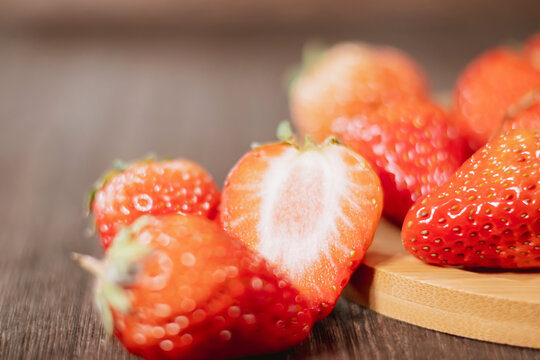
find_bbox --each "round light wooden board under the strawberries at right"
[343,220,540,348]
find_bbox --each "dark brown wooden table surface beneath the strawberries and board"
[0,24,540,360]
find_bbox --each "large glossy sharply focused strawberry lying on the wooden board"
[402,129,540,269]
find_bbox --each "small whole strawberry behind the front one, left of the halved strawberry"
[90,159,219,248]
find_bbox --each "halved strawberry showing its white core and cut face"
[220,131,382,318]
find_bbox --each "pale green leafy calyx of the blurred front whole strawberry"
[72,216,150,335]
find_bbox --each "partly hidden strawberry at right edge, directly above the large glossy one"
[501,88,540,132]
